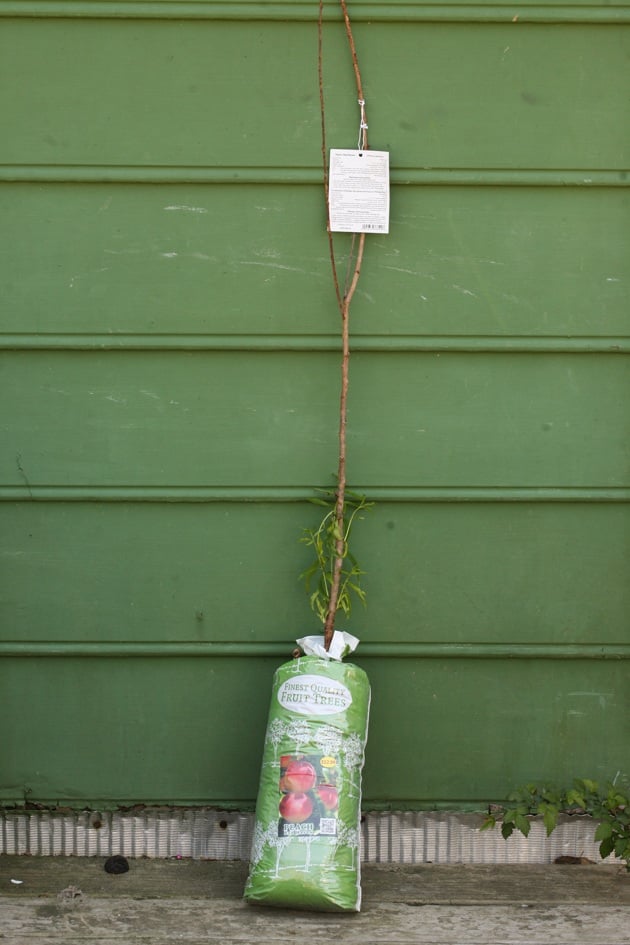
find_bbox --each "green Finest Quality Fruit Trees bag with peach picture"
[245,632,370,912]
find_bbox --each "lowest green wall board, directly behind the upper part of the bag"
[0,658,627,809]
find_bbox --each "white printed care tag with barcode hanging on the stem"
[328,148,389,233]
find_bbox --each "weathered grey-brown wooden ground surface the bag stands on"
[0,856,630,945]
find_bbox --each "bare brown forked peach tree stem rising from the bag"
[318,0,368,650]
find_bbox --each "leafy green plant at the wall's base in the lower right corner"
[481,778,630,871]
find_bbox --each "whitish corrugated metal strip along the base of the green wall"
[0,808,616,864]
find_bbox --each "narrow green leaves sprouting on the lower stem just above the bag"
[300,489,374,625]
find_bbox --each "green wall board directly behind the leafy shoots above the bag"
[0,501,630,644]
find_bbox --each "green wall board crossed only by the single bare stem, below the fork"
[0,352,630,489]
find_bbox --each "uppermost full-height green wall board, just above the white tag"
[0,19,630,169]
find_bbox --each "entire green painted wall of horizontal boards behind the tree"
[0,0,630,808]
